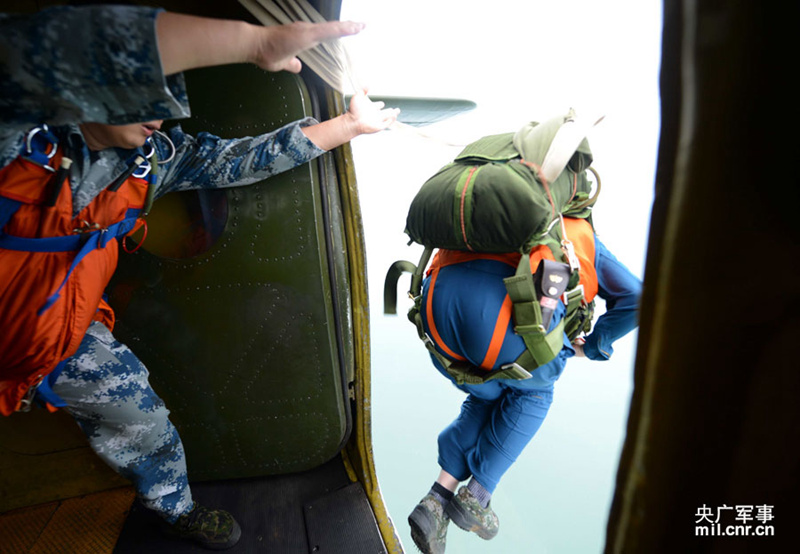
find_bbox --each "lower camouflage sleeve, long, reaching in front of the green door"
[156,117,325,197]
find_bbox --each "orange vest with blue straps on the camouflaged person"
[0,144,148,415]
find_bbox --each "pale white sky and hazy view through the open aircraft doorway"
[341,0,661,554]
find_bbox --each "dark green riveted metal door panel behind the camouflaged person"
[110,66,351,480]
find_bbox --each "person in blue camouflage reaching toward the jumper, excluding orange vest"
[0,6,397,549]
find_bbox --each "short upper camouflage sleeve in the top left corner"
[0,5,189,126]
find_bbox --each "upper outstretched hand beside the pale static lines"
[252,21,364,73]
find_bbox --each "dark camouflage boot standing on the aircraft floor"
[164,502,242,550]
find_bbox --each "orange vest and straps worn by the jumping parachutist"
[426,217,598,370]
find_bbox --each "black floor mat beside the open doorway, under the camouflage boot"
[114,457,386,554]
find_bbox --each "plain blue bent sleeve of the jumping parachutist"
[583,238,642,360]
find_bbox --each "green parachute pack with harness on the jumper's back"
[384,110,600,384]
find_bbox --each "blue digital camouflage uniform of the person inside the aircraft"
[0,6,323,522]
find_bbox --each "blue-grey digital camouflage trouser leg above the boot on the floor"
[52,322,192,523]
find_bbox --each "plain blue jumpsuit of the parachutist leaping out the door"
[422,237,641,492]
